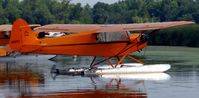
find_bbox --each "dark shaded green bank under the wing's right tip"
[150,24,199,47]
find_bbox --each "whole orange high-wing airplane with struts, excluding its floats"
[9,19,193,67]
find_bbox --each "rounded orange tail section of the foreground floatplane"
[9,19,39,52]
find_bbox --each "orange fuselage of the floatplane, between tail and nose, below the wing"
[33,33,147,56]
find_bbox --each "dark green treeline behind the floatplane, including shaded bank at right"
[0,0,199,47]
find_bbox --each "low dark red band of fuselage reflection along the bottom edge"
[21,90,147,98]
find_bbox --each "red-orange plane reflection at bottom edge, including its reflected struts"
[20,79,147,98]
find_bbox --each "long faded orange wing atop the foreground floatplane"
[34,21,194,33]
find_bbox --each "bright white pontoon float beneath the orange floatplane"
[95,63,171,74]
